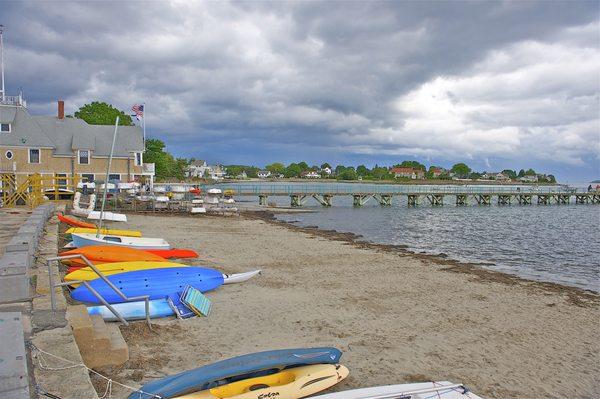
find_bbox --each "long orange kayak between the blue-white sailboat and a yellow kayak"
[59,245,166,267]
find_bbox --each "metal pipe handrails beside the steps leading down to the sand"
[46,254,152,329]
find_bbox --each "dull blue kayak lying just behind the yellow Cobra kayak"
[129,347,342,399]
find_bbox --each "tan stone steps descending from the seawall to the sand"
[67,305,129,368]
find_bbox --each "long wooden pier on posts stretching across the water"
[204,183,600,207]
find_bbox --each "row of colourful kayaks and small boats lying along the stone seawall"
[59,215,260,321]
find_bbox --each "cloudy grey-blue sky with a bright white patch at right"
[0,1,600,182]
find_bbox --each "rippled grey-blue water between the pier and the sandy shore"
[269,196,600,292]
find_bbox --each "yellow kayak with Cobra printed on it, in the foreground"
[176,364,348,399]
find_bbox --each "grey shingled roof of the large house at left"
[0,106,144,157]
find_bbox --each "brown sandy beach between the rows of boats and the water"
[91,215,600,398]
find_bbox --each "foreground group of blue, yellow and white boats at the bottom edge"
[129,347,480,399]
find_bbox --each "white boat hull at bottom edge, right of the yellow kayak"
[313,381,482,399]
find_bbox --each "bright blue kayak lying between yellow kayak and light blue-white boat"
[71,266,223,304]
